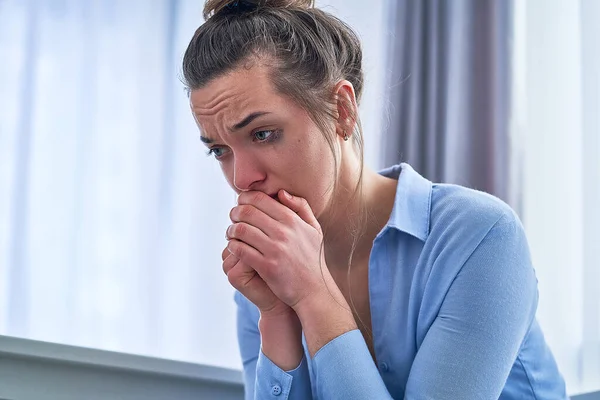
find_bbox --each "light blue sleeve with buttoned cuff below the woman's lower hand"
[235,292,312,400]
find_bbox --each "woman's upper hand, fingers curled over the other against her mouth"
[227,190,333,308]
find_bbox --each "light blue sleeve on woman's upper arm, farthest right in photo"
[405,211,538,400]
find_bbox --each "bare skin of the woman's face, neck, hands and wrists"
[190,63,396,370]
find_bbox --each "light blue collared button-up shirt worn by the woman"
[235,164,567,400]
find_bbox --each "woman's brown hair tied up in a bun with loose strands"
[183,0,364,338]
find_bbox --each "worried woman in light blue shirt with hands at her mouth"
[183,0,566,400]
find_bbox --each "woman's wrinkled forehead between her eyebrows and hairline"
[190,65,280,119]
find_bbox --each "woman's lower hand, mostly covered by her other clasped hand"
[221,248,293,317]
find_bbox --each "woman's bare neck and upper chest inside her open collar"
[319,163,396,273]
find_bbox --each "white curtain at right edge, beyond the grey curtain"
[513,0,600,394]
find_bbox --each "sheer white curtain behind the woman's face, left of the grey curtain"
[0,0,384,368]
